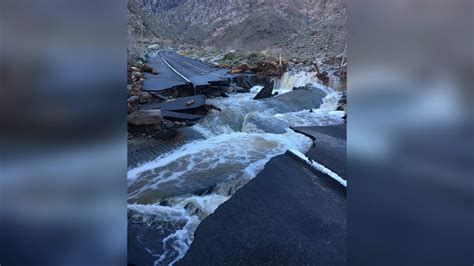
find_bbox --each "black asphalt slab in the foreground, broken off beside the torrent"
[177,151,347,265]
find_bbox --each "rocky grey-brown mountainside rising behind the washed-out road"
[128,0,346,60]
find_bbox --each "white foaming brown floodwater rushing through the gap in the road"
[128,76,344,265]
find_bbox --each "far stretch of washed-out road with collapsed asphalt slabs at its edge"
[130,51,274,133]
